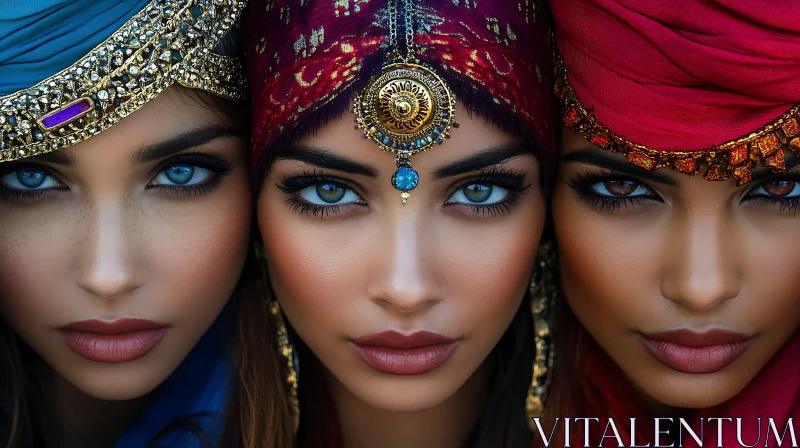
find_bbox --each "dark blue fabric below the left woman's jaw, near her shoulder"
[114,300,237,448]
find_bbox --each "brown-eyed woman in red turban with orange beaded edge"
[541,0,800,447]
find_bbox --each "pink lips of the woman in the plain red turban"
[640,329,752,374]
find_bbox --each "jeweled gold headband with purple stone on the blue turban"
[0,0,246,162]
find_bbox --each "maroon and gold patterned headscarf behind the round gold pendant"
[245,0,555,179]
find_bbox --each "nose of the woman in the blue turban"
[79,201,139,299]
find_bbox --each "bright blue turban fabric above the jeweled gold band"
[0,0,149,96]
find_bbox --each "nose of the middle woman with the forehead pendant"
[368,216,444,314]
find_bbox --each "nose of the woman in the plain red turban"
[661,215,741,312]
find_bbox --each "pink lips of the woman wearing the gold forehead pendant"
[353,331,458,375]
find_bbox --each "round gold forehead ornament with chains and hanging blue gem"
[353,0,458,204]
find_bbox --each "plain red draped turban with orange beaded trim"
[549,0,800,184]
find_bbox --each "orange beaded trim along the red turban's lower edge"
[554,51,800,186]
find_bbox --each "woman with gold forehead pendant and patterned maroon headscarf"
[245,0,555,448]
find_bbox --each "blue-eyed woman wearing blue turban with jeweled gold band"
[0,0,292,448]
